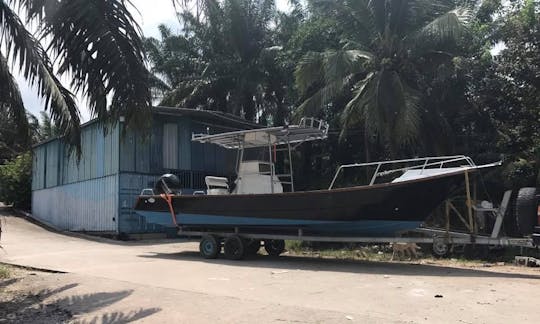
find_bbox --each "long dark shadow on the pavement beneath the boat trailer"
[139,251,540,279]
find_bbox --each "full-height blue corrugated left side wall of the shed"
[32,123,119,232]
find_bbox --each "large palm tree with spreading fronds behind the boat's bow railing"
[295,0,472,159]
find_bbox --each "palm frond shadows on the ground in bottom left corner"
[0,278,161,324]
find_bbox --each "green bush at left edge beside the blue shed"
[0,152,32,210]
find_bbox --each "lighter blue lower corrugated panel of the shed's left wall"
[32,175,118,232]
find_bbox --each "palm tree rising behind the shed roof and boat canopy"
[146,0,282,120]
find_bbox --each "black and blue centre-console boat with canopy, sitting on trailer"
[134,118,500,237]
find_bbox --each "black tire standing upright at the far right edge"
[514,187,538,235]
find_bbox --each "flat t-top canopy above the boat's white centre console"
[191,118,328,149]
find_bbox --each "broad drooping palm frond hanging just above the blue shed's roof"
[33,0,151,127]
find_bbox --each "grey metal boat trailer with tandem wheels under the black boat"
[178,190,540,260]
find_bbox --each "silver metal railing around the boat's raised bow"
[328,155,475,190]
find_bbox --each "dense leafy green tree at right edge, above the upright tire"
[468,1,540,188]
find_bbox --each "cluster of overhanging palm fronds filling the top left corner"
[0,0,151,151]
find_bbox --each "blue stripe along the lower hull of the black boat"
[136,210,421,236]
